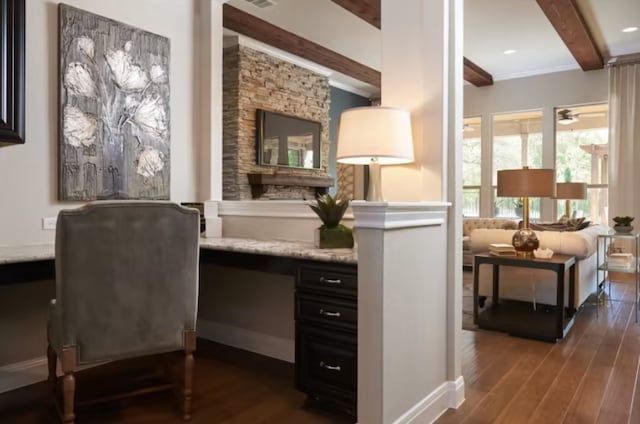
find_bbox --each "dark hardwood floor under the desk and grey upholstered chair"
[0,339,352,424]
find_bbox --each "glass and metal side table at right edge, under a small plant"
[596,230,640,323]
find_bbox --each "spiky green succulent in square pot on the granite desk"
[309,194,353,249]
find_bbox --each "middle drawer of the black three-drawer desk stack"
[296,293,358,331]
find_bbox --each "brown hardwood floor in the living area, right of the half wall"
[437,282,640,424]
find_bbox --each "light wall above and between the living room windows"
[464,69,608,220]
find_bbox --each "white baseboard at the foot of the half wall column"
[394,376,464,424]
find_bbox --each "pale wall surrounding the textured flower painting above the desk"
[0,0,198,246]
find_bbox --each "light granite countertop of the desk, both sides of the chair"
[0,237,357,265]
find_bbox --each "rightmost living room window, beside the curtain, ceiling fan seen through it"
[556,104,609,224]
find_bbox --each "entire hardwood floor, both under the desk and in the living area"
[0,283,640,424]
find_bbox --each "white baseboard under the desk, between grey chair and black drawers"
[197,319,295,363]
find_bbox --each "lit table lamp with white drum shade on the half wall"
[336,106,413,202]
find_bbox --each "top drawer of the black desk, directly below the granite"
[297,264,358,296]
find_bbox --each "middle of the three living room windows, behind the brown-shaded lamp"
[492,111,542,219]
